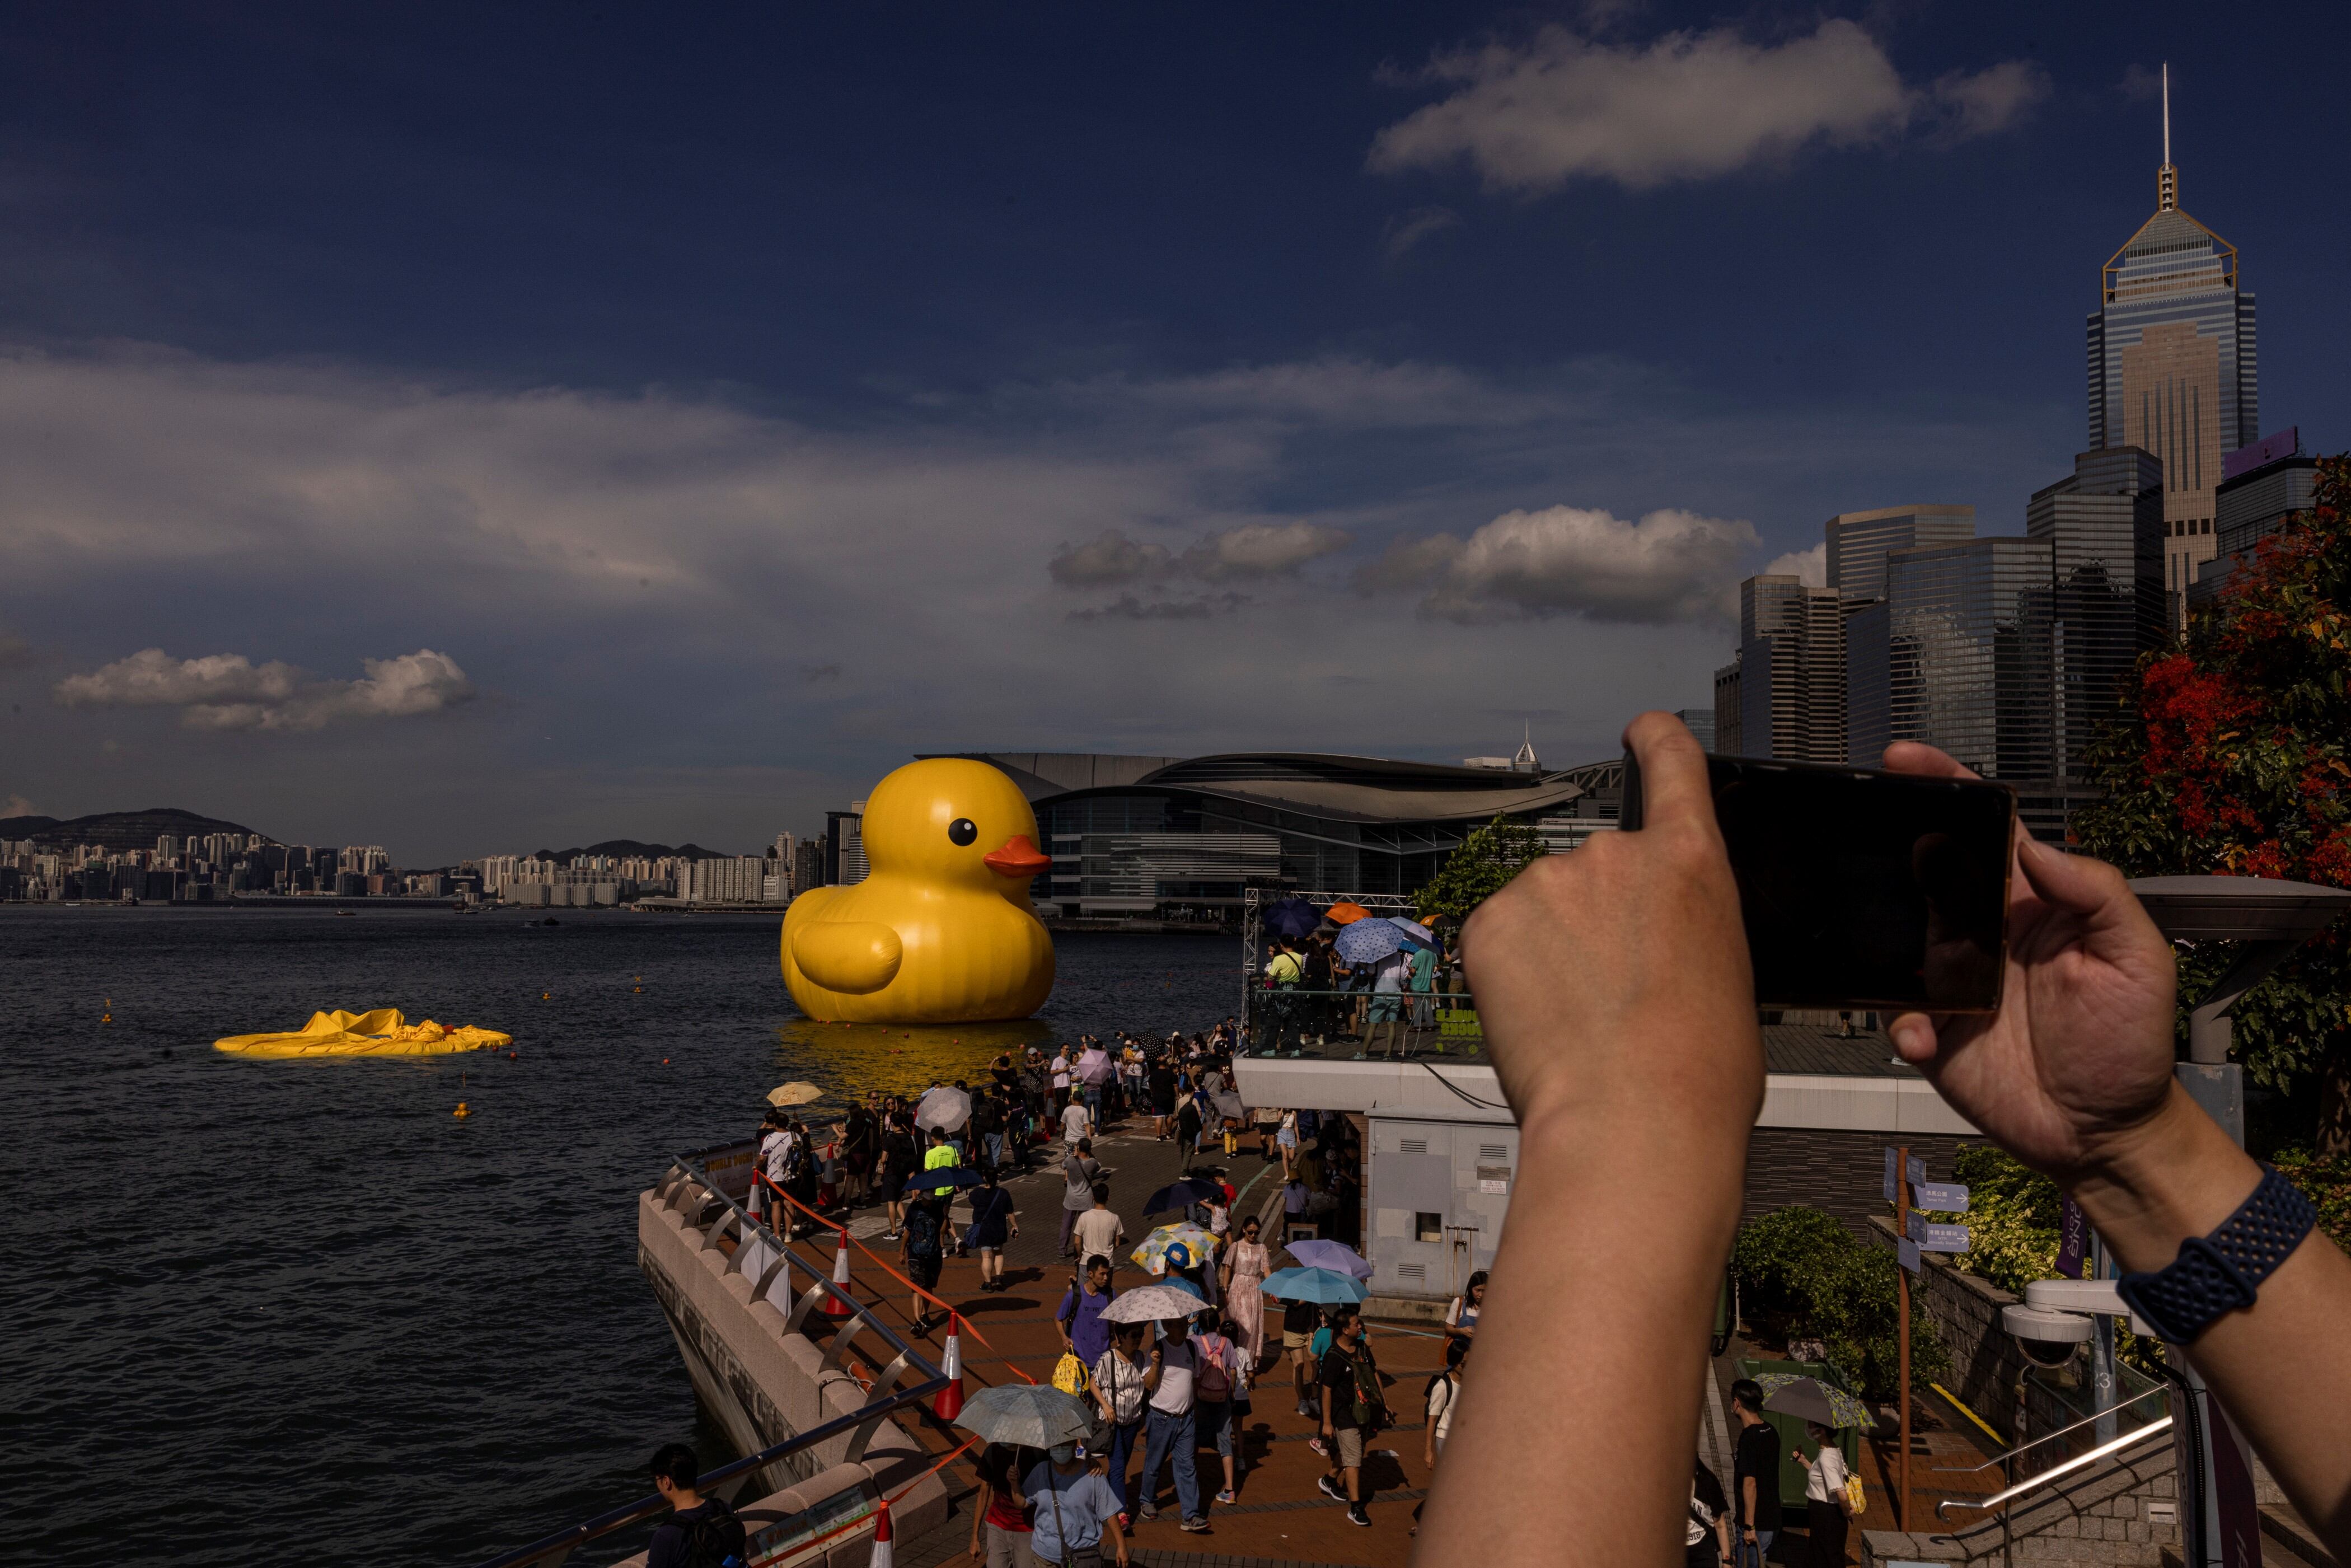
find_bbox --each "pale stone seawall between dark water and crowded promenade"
[623,1185,948,1568]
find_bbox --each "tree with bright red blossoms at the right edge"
[2076,456,2351,1159]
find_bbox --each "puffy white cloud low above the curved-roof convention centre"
[1356,505,1756,625]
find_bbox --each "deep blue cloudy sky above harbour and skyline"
[0,4,2351,863]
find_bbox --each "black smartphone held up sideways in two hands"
[1618,752,2017,1013]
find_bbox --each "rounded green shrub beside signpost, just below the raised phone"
[1730,1206,1951,1399]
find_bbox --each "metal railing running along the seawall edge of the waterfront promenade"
[463,1143,948,1568]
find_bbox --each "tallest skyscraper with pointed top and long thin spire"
[2090,66,2259,625]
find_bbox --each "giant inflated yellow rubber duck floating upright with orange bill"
[783,757,1053,1023]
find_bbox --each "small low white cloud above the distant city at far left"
[57,649,472,731]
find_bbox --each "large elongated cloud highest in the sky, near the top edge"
[1371,19,2048,193]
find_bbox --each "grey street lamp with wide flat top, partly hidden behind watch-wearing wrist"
[2125,877,2351,1568]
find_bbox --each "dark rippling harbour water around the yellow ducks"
[0,905,1239,1568]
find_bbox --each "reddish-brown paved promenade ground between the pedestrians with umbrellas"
[761,1119,1441,1568]
